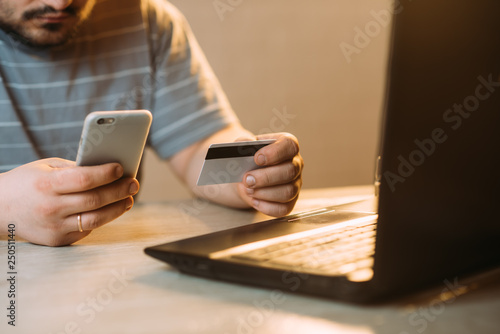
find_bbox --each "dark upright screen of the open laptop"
[375,0,500,284]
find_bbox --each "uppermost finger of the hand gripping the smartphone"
[45,163,123,194]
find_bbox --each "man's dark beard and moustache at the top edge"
[0,0,95,49]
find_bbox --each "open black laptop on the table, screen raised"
[145,0,500,303]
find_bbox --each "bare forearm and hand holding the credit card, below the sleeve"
[170,124,304,217]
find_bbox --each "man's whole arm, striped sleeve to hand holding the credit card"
[146,2,303,216]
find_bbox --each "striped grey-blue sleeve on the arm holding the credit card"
[143,0,238,159]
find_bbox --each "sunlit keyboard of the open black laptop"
[232,219,376,276]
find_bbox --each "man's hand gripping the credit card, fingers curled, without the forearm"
[238,133,304,217]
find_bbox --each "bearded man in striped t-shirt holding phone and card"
[0,0,303,246]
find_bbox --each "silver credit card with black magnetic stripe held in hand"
[197,139,276,186]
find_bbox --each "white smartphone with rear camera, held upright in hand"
[76,110,153,177]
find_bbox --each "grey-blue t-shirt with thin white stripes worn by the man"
[0,0,237,172]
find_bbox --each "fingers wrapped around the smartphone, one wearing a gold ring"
[31,164,139,246]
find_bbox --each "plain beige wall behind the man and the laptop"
[142,0,390,200]
